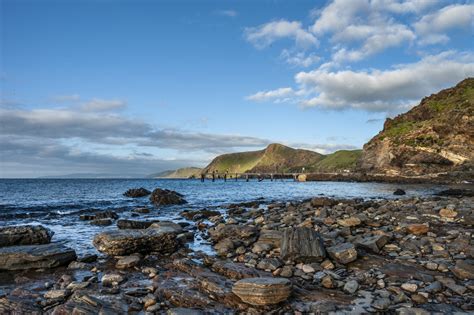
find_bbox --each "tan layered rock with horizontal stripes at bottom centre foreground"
[232,277,291,305]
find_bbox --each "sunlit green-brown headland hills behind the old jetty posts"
[203,143,361,173]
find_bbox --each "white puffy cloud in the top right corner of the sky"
[414,4,474,44]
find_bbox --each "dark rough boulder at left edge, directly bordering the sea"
[0,225,54,247]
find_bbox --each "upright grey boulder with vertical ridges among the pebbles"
[280,227,326,263]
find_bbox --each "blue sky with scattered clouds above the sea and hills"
[0,0,474,178]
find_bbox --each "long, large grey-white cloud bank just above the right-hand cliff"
[246,52,474,112]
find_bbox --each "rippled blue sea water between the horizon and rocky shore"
[0,179,447,254]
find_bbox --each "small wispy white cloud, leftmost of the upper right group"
[244,20,318,49]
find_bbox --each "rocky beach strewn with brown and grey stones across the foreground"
[0,187,474,314]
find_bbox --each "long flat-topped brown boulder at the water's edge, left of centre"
[93,226,181,256]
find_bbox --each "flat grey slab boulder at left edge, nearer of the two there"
[0,243,76,270]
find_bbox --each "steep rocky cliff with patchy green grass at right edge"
[360,78,474,175]
